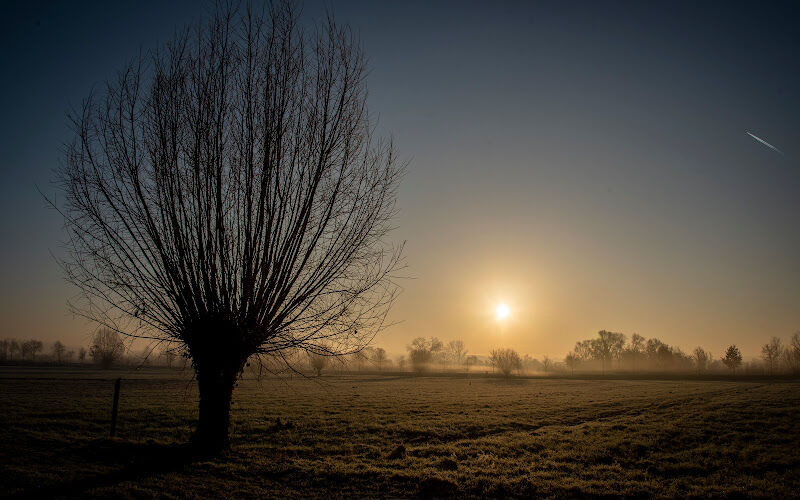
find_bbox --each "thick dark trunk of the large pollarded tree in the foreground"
[192,364,241,452]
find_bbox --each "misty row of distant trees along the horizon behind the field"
[0,329,800,376]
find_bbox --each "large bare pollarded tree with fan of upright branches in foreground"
[50,1,402,449]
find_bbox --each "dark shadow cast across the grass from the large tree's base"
[13,439,213,498]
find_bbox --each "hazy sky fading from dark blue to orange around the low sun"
[0,0,800,358]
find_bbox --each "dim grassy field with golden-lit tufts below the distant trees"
[0,368,800,497]
